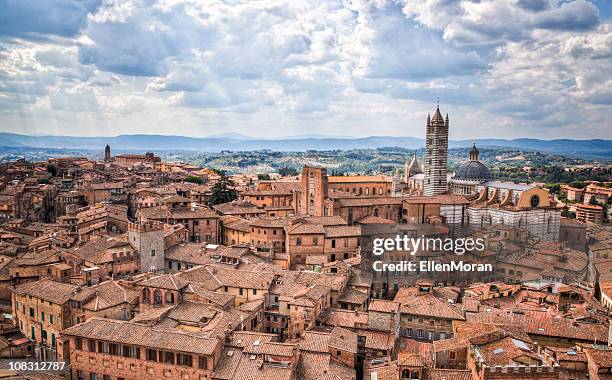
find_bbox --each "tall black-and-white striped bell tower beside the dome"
[423,106,448,196]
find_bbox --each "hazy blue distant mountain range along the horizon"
[0,133,612,159]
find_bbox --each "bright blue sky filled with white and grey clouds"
[0,0,612,139]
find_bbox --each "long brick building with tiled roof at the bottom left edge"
[59,318,223,380]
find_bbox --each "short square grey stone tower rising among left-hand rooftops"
[128,221,165,273]
